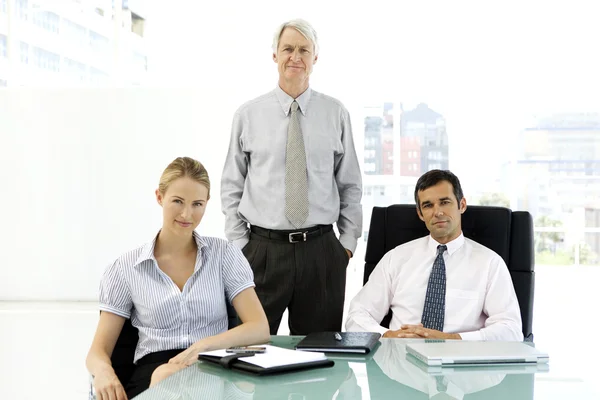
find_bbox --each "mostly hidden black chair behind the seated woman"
[110,301,240,386]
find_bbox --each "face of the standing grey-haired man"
[273,28,317,84]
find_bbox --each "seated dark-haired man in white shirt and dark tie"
[346,170,523,341]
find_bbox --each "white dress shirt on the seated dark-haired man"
[346,233,523,341]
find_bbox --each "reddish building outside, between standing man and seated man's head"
[362,102,448,241]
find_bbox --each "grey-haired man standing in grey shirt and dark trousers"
[221,19,362,335]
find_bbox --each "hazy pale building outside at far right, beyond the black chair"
[505,113,600,262]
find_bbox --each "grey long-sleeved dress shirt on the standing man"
[221,86,362,252]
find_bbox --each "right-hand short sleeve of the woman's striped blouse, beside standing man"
[223,242,255,302]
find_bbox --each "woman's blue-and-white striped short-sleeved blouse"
[100,232,254,362]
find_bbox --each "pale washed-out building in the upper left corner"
[0,0,148,87]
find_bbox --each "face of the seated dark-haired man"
[417,181,467,244]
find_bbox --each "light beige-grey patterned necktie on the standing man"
[285,100,308,228]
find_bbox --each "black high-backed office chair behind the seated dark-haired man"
[363,204,535,341]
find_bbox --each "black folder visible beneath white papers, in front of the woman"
[198,354,335,376]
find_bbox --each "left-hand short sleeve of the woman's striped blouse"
[99,260,133,318]
